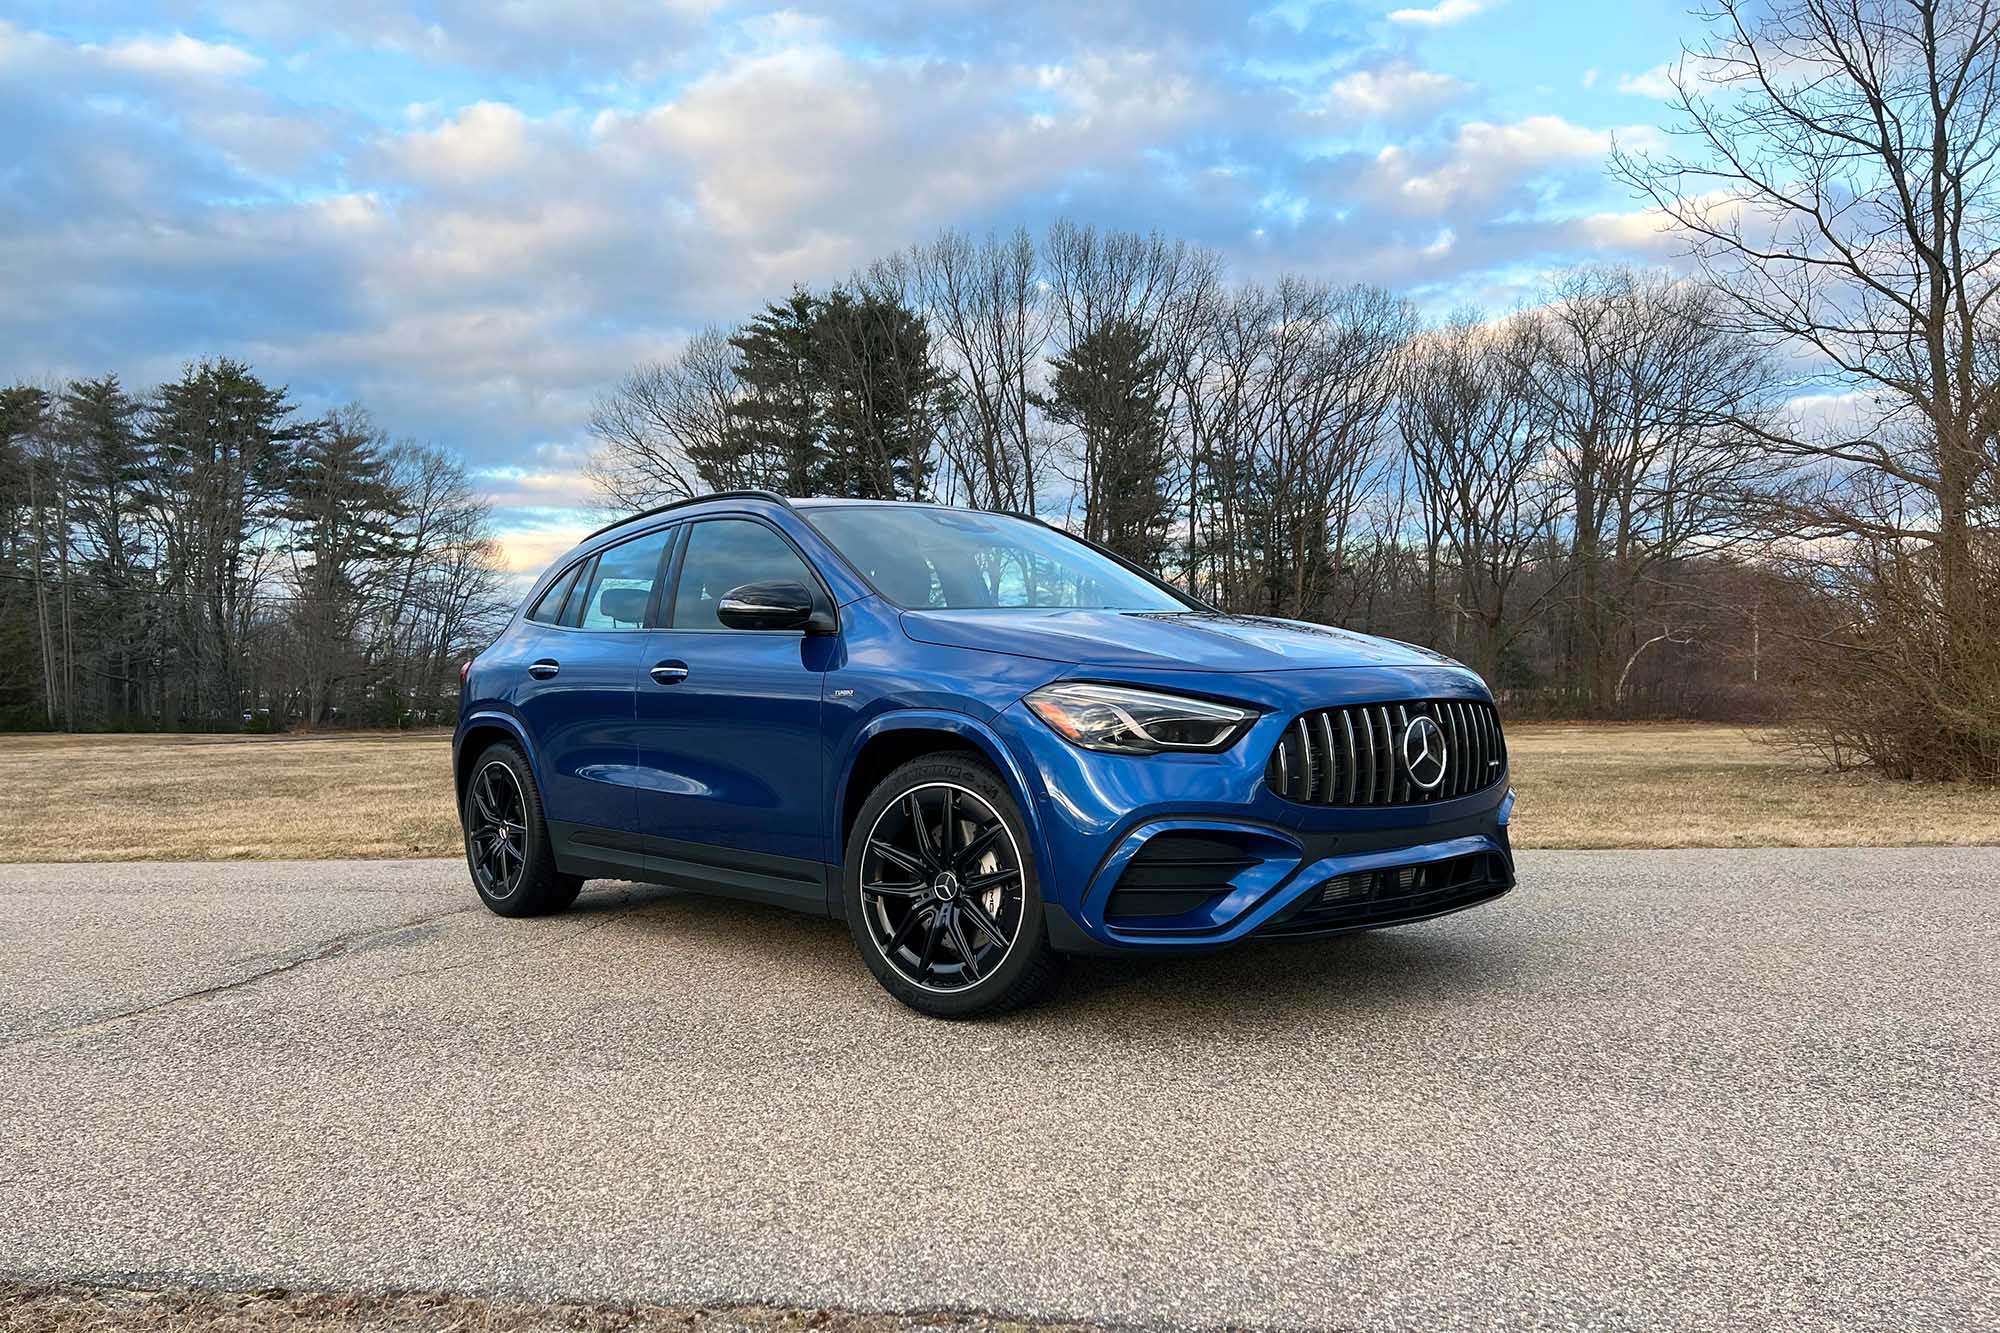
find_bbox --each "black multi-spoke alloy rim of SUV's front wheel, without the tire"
[860,783,1026,993]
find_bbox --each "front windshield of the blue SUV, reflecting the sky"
[806,504,1188,610]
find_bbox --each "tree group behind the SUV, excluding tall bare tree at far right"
[592,243,1800,717]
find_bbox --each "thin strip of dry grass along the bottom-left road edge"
[0,1281,1084,1333]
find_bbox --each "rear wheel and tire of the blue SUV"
[458,741,584,917]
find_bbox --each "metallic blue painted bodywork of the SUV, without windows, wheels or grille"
[458,498,1512,951]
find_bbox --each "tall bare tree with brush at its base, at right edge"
[1614,0,2000,777]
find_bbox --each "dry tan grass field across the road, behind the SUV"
[0,723,2000,861]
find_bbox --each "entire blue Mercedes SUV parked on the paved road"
[454,492,1514,1017]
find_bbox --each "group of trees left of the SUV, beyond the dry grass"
[0,360,506,731]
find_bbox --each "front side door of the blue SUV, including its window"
[638,516,832,907]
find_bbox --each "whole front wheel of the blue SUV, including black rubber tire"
[842,755,1062,1019]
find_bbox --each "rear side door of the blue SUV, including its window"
[516,528,674,875]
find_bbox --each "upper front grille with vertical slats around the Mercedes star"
[1264,699,1506,807]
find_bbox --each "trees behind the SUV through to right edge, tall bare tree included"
[592,0,2000,777]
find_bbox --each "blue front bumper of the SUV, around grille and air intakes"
[1004,667,1514,953]
